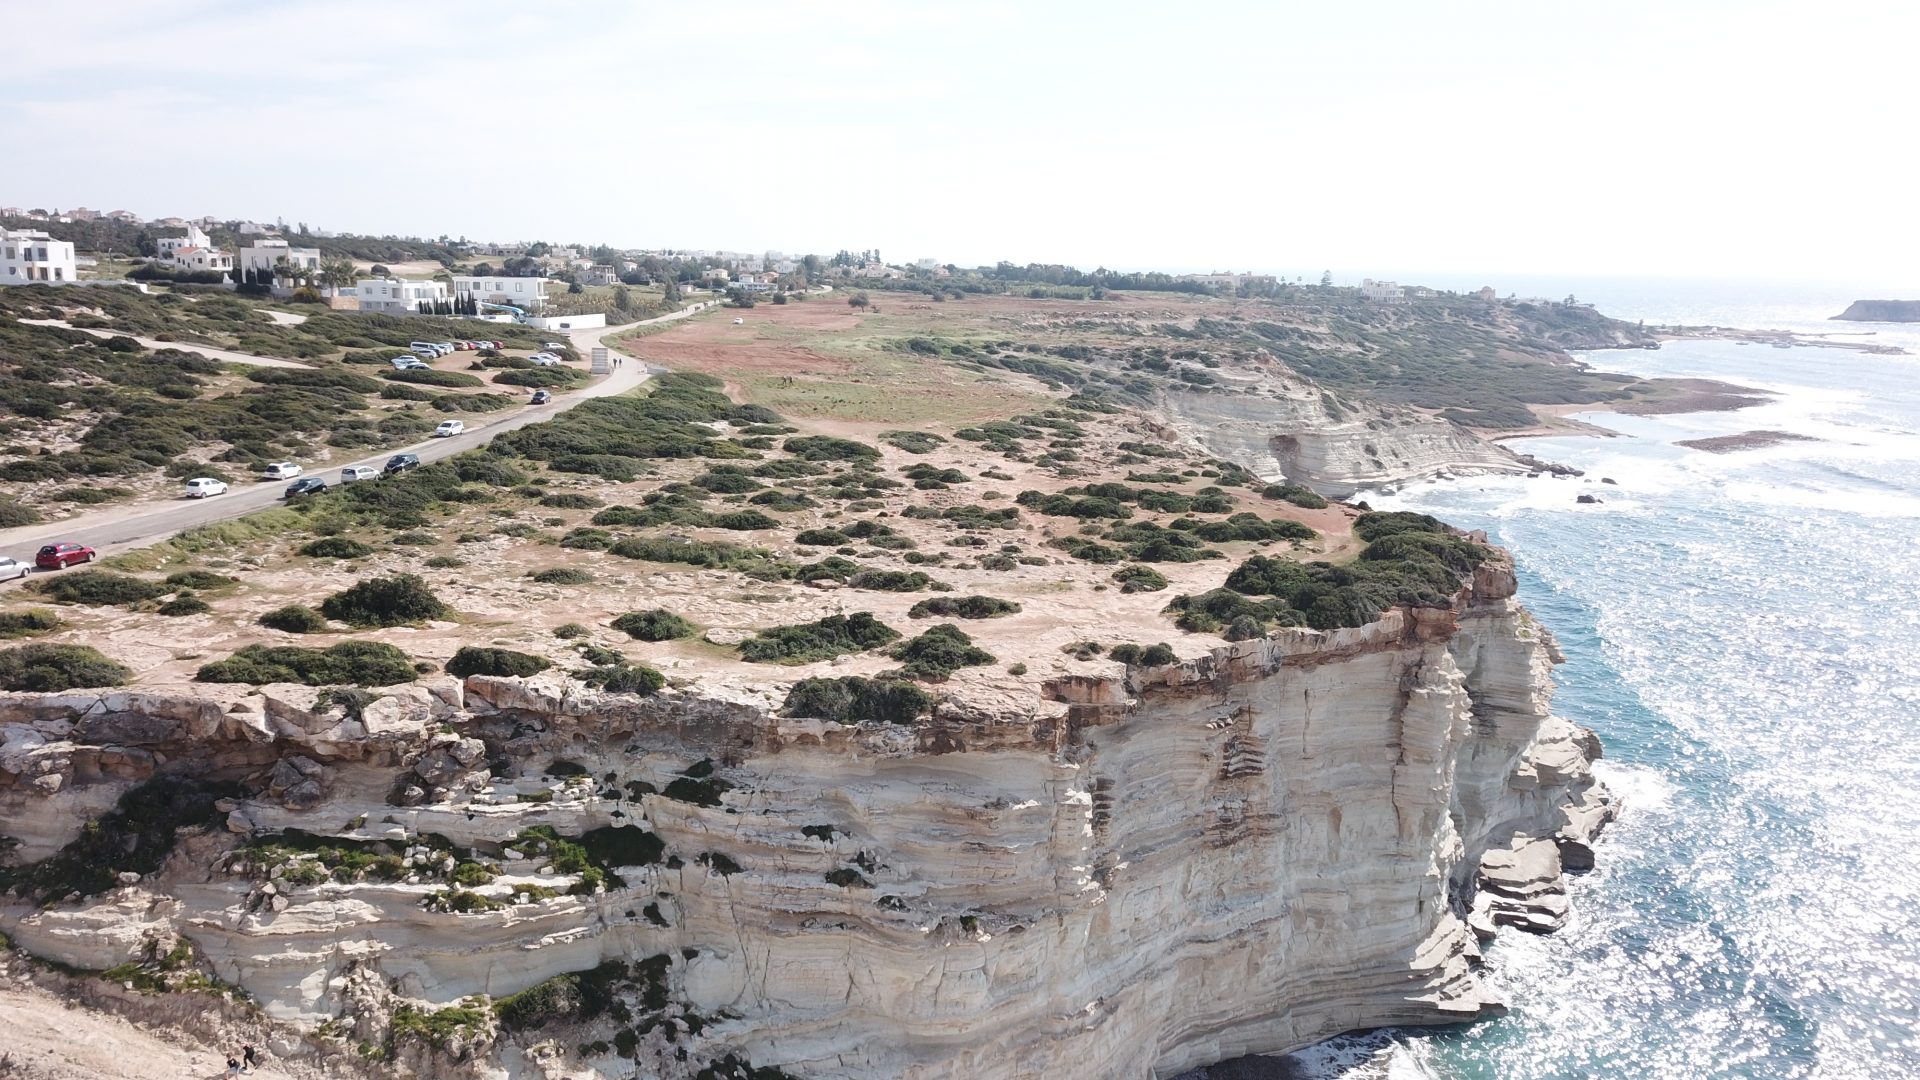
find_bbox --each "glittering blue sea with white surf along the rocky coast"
[1294,282,1920,1080]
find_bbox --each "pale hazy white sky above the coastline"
[0,0,1920,286]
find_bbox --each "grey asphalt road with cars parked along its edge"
[0,304,710,563]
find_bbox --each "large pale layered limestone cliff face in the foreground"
[0,565,1611,1080]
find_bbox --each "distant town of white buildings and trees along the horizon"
[0,206,1572,319]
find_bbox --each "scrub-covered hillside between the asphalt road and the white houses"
[0,286,560,507]
